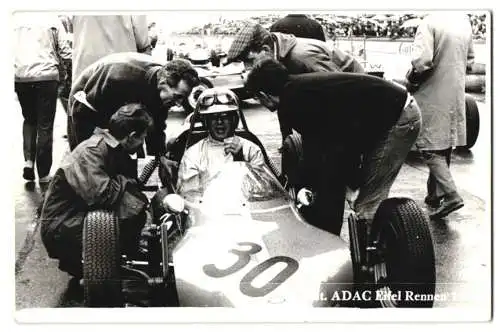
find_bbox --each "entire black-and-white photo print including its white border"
[5,9,493,323]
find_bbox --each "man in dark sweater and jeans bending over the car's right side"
[246,58,421,234]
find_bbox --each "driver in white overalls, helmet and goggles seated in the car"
[177,88,265,194]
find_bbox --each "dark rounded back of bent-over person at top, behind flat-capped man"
[270,14,326,41]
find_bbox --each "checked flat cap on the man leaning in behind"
[227,22,270,63]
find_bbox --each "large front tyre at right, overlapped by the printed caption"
[370,198,436,308]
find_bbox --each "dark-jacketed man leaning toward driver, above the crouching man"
[68,52,199,155]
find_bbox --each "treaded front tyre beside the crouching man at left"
[82,210,124,308]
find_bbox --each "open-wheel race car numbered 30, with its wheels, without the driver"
[83,94,435,307]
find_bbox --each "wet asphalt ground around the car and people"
[9,97,492,315]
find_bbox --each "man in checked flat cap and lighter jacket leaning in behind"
[227,23,363,140]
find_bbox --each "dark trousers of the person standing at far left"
[15,81,58,177]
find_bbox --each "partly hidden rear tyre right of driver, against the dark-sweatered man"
[281,131,304,199]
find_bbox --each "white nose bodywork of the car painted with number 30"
[173,162,352,307]
